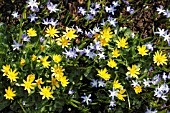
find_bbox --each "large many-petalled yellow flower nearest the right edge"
[153,51,168,66]
